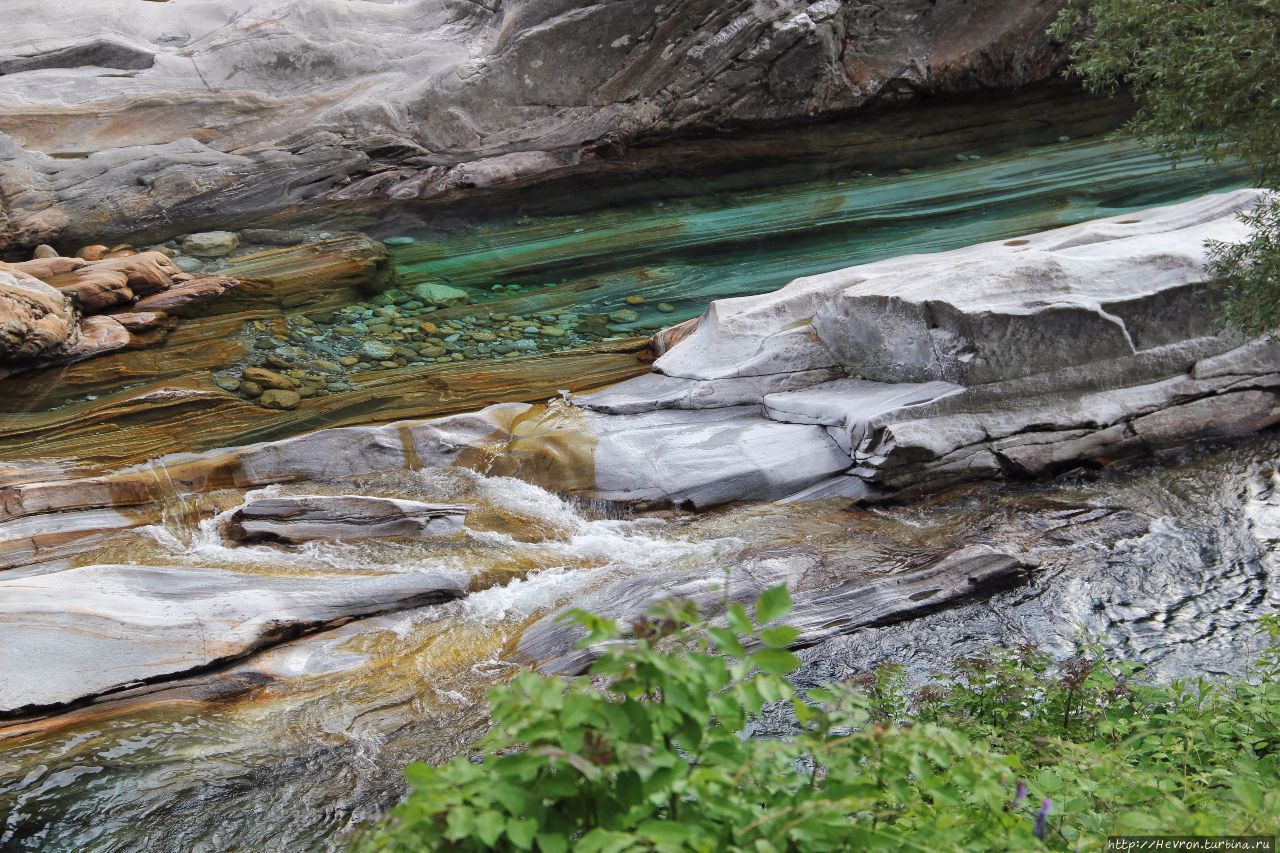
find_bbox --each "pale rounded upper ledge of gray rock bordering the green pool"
[654,190,1261,386]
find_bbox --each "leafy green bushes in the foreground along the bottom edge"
[362,589,1280,853]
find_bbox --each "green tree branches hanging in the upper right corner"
[1051,0,1280,332]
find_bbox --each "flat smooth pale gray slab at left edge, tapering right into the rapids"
[0,565,470,716]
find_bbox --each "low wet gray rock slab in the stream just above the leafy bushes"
[517,546,1034,675]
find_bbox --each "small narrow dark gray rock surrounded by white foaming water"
[227,494,467,544]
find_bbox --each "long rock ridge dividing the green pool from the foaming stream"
[0,190,1280,565]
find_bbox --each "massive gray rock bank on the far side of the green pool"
[0,0,1064,248]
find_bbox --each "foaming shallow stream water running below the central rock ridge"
[0,435,1280,850]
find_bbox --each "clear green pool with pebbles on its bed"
[225,138,1245,392]
